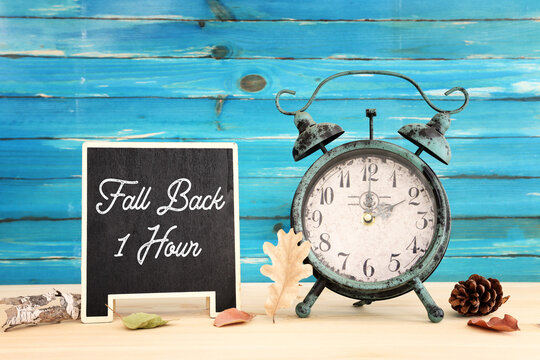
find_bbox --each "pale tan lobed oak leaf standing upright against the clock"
[261,229,313,322]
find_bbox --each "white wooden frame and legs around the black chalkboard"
[81,141,241,323]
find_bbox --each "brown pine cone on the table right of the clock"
[448,274,510,316]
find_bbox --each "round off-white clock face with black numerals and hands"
[301,148,440,282]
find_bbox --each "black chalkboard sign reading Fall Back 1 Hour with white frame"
[81,142,240,323]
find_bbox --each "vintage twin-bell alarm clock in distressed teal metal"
[276,71,469,322]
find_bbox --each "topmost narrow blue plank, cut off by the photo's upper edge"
[0,0,540,21]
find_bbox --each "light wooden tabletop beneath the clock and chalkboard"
[0,283,540,360]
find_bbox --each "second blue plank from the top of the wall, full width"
[0,18,540,59]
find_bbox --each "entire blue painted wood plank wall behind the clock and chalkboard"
[0,0,540,284]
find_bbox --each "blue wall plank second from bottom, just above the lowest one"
[0,217,540,262]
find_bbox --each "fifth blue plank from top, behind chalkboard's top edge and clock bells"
[4,137,540,180]
